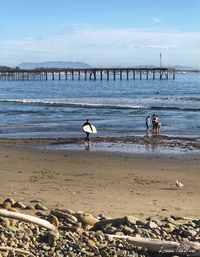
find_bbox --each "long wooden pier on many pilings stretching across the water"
[0,68,176,81]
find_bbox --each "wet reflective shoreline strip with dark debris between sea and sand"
[0,135,200,154]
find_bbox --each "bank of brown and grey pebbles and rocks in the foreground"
[0,198,200,257]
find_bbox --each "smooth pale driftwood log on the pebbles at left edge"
[0,209,56,230]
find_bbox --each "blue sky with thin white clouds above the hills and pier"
[0,0,200,68]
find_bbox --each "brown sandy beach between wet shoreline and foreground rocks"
[0,137,200,218]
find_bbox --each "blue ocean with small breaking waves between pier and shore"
[0,74,200,140]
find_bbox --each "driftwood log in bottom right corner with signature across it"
[107,234,200,256]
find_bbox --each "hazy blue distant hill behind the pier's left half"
[18,61,91,70]
